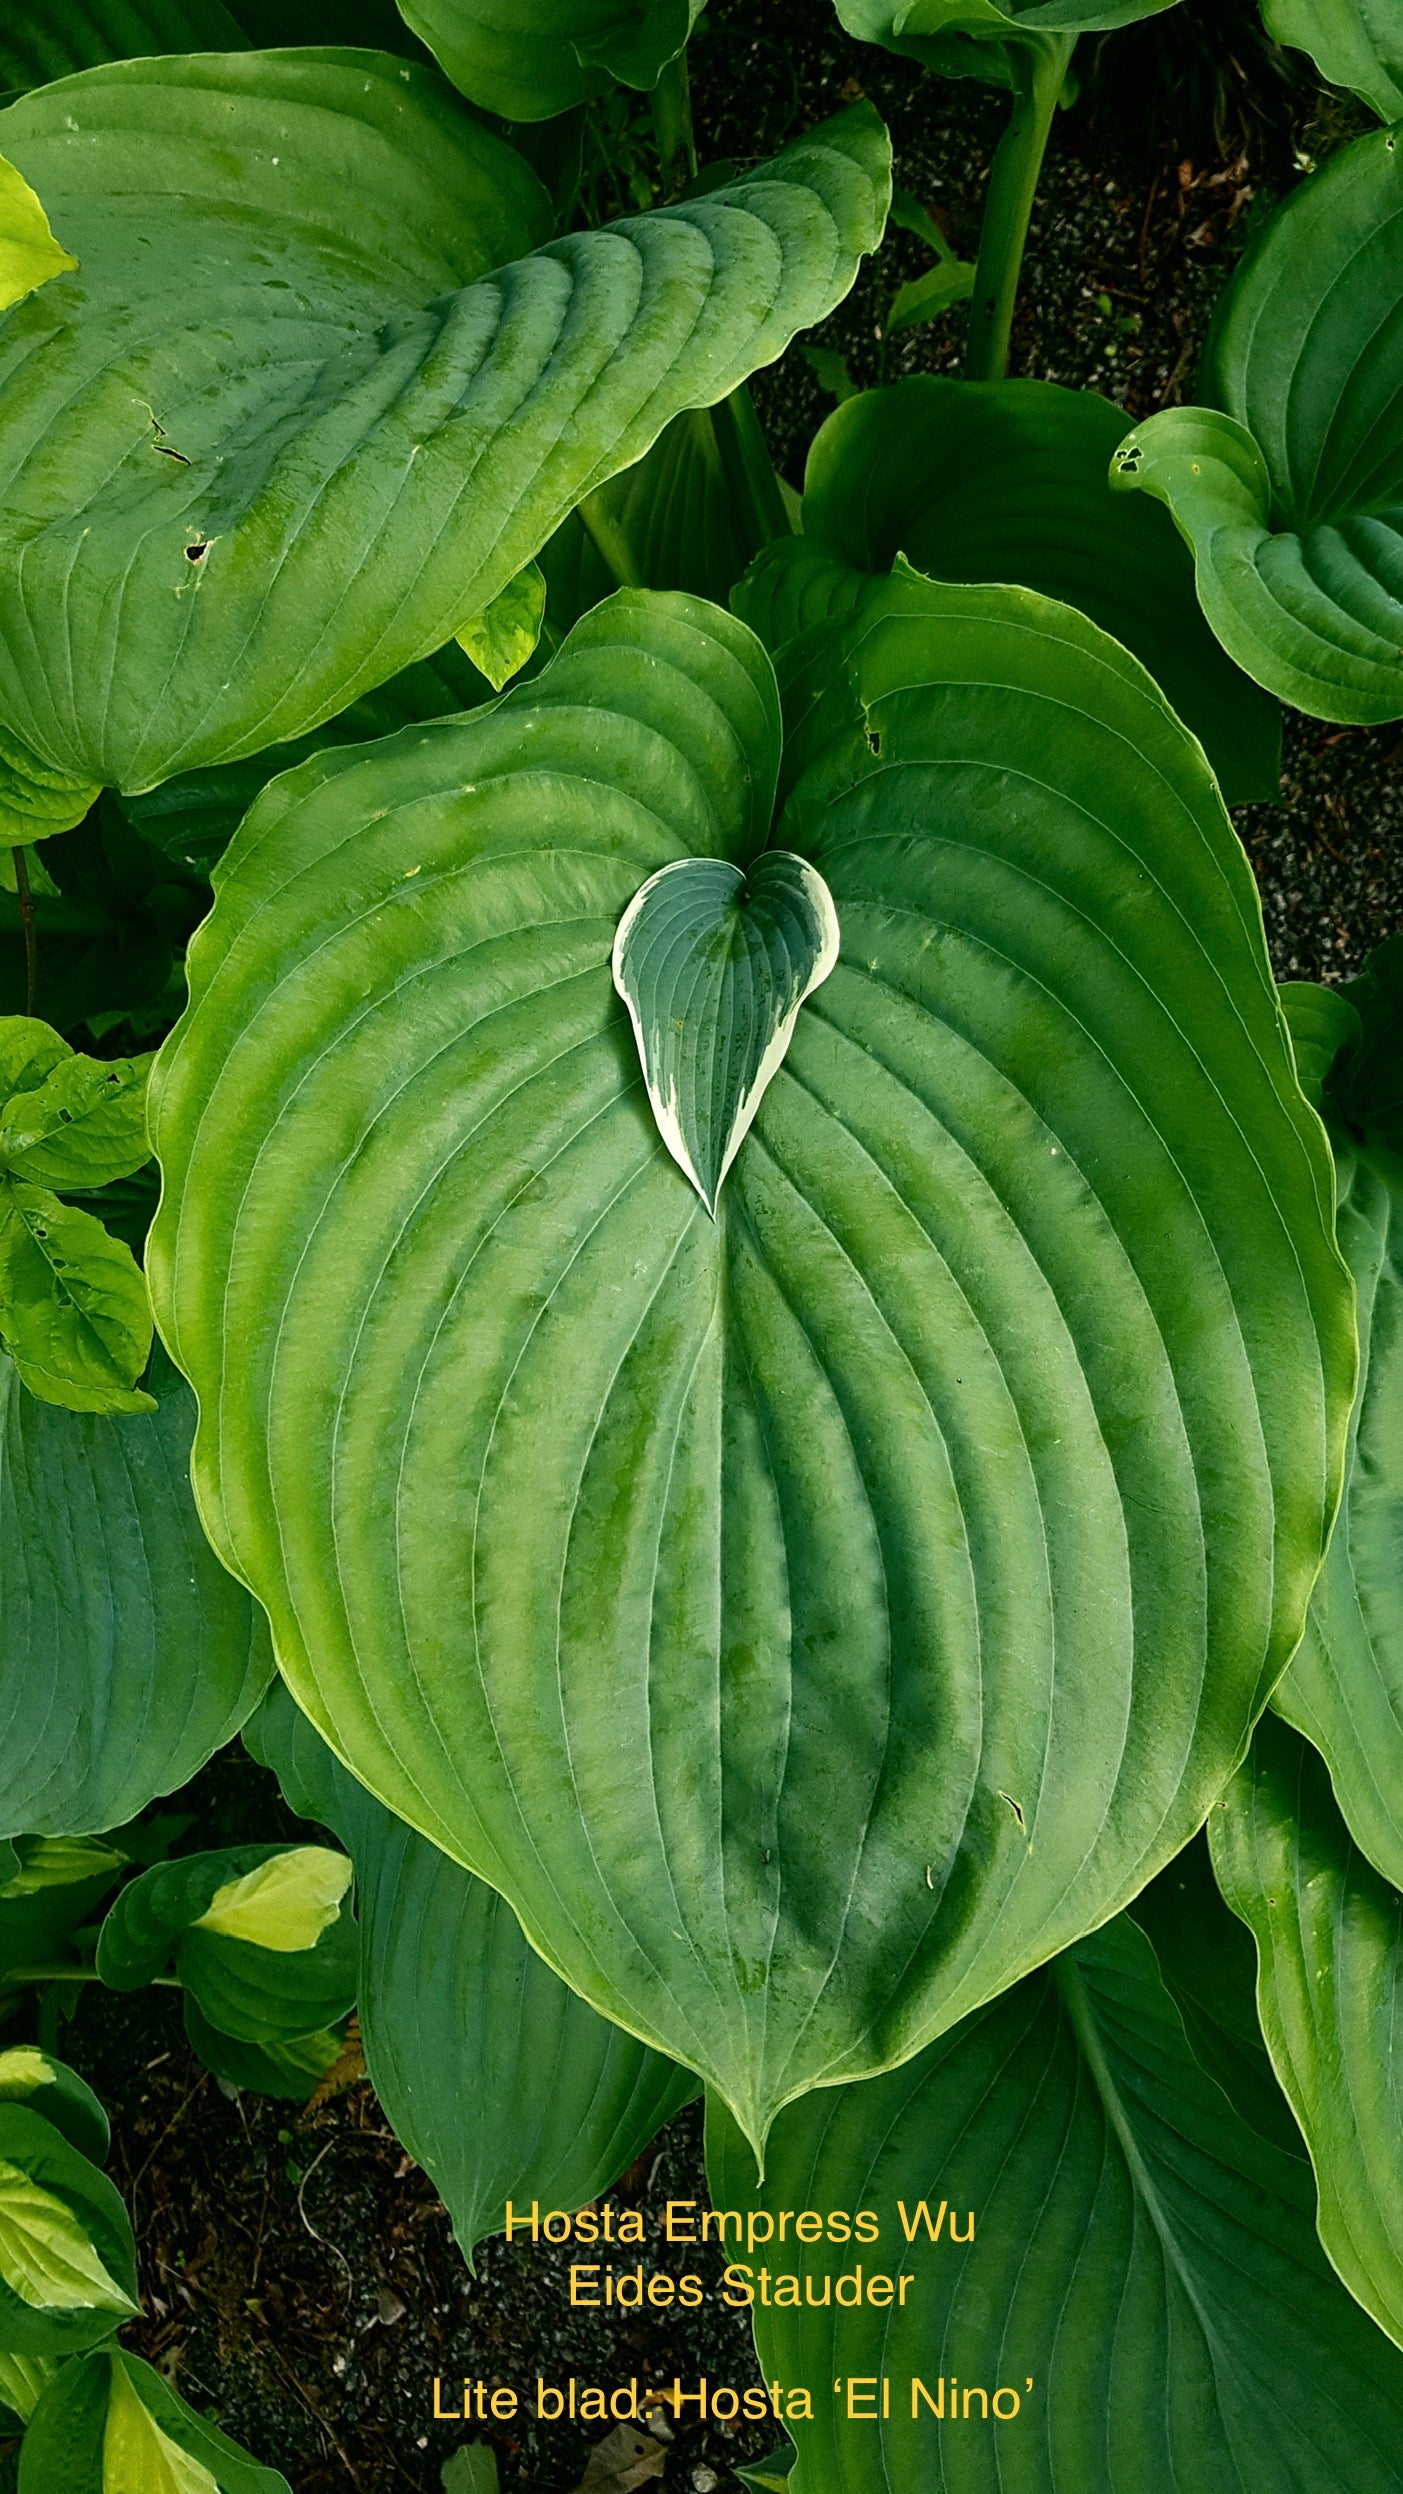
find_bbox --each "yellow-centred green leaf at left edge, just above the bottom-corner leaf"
[0,2102,137,2357]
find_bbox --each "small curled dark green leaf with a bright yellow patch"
[97,1846,356,2045]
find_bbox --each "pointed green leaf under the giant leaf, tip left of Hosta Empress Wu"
[247,1686,698,2260]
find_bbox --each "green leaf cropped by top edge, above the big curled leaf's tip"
[401,0,705,122]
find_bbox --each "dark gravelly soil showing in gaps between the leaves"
[0,0,1403,2494]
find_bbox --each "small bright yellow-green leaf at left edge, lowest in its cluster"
[0,1177,155,1412]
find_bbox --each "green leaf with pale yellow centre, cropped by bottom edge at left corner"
[20,2347,289,2494]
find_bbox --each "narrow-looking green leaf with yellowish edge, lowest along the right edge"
[1209,1716,1403,2344]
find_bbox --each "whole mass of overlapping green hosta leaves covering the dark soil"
[0,0,1403,2494]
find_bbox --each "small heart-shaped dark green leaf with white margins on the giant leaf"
[613,848,840,1217]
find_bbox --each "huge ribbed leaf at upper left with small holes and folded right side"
[0,52,890,791]
